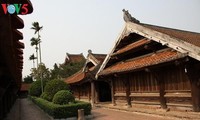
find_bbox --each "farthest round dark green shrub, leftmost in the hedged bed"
[28,80,47,97]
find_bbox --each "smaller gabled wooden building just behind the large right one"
[65,50,106,105]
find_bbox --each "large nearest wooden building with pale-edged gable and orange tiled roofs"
[96,15,200,112]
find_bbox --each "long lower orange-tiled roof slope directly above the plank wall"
[99,50,185,75]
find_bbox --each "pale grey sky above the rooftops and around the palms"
[20,0,200,76]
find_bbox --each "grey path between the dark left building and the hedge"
[5,99,50,120]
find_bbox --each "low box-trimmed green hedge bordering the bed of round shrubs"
[30,97,91,119]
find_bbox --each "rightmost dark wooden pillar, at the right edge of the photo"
[185,63,200,112]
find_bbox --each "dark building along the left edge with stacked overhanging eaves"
[0,0,33,119]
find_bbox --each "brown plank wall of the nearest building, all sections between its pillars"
[113,65,191,108]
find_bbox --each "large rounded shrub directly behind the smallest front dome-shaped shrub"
[41,80,69,101]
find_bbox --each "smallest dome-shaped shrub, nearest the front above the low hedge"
[53,90,75,105]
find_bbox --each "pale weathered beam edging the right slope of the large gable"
[126,22,200,60]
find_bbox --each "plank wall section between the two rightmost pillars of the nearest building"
[162,66,192,108]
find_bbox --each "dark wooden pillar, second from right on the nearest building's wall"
[153,71,167,109]
